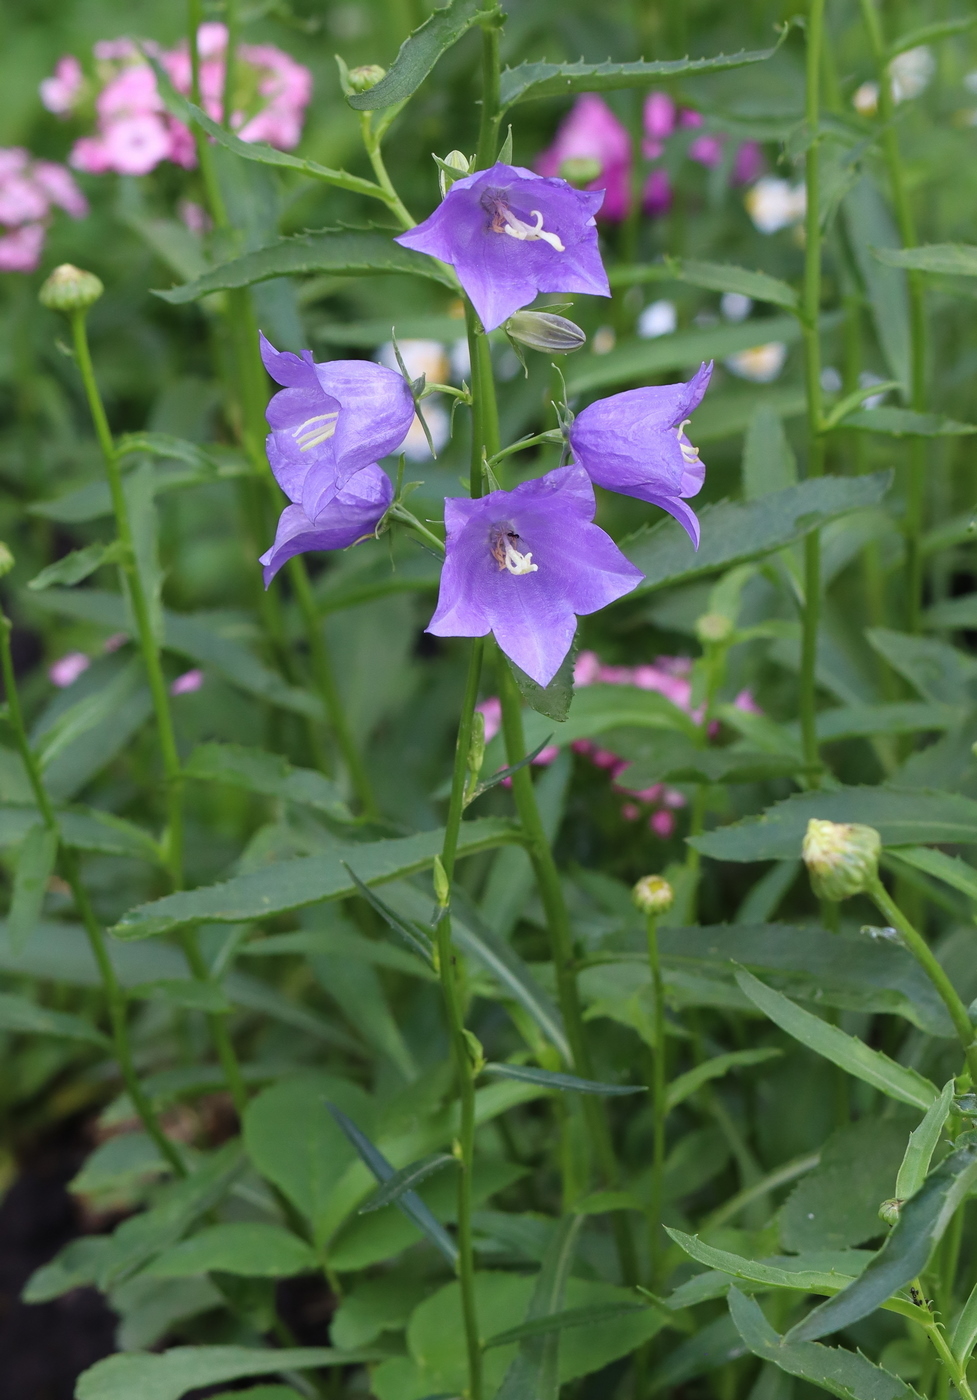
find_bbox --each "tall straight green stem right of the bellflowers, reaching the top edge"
[801,0,824,785]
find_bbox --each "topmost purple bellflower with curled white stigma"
[396,165,610,330]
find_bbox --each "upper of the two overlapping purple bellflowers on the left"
[260,336,414,518]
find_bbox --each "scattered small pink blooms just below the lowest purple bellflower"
[477,651,761,839]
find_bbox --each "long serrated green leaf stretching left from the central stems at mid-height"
[113,818,516,938]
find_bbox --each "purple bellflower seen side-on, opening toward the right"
[570,361,712,549]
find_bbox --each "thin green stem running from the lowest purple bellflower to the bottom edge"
[437,637,486,1400]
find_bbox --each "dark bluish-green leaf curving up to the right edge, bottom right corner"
[787,1144,977,1341]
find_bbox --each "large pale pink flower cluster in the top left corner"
[41,22,312,175]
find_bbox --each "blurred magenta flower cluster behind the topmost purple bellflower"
[536,92,763,223]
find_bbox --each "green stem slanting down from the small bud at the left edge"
[0,612,188,1176]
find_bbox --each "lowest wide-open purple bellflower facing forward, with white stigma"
[427,466,644,686]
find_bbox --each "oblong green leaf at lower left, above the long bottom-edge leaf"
[147,1221,319,1278]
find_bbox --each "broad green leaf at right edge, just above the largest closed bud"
[690,787,977,861]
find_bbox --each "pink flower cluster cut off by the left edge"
[0,146,88,272]
